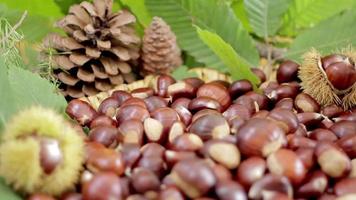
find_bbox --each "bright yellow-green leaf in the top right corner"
[280,0,355,36]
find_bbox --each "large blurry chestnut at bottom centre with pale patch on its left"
[170,159,216,198]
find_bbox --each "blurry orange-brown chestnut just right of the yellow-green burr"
[86,142,125,175]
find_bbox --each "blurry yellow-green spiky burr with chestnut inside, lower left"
[0,107,84,196]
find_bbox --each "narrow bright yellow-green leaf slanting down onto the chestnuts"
[197,27,259,86]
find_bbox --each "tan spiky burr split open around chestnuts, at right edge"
[299,49,356,109]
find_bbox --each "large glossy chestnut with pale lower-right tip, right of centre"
[237,118,287,157]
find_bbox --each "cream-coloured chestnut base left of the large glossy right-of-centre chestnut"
[203,140,241,169]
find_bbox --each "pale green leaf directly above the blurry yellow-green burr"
[9,67,66,111]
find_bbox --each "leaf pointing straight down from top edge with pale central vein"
[244,0,291,39]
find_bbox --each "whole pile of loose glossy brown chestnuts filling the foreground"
[31,56,356,200]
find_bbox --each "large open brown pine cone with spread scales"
[44,0,141,98]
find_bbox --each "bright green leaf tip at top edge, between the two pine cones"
[120,0,152,27]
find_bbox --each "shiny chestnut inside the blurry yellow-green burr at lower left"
[40,138,63,174]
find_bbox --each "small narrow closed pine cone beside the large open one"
[142,17,182,74]
